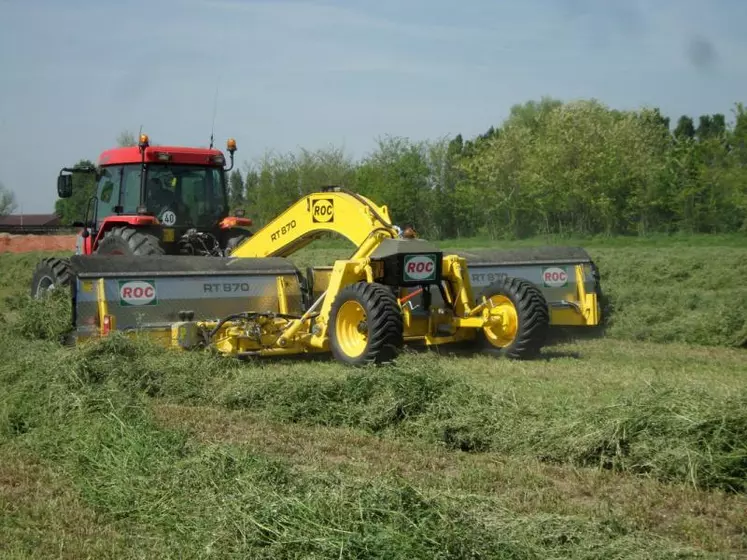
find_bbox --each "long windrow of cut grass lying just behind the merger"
[10,328,736,492]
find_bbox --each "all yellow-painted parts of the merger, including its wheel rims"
[71,191,599,364]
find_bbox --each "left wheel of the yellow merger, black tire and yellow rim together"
[329,282,404,365]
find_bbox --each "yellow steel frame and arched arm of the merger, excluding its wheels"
[87,187,598,356]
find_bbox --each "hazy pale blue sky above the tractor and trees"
[0,0,747,213]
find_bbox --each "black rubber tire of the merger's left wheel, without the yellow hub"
[328,282,404,366]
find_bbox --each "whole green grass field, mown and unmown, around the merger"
[0,236,747,559]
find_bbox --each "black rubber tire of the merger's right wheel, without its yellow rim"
[477,275,550,360]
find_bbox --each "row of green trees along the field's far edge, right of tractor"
[52,98,747,239]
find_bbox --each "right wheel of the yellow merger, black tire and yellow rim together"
[477,276,550,359]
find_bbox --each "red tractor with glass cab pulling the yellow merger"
[31,134,252,297]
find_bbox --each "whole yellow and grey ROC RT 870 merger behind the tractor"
[38,187,600,365]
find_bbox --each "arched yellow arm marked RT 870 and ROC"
[231,189,397,259]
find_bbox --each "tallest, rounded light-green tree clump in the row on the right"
[463,100,669,237]
